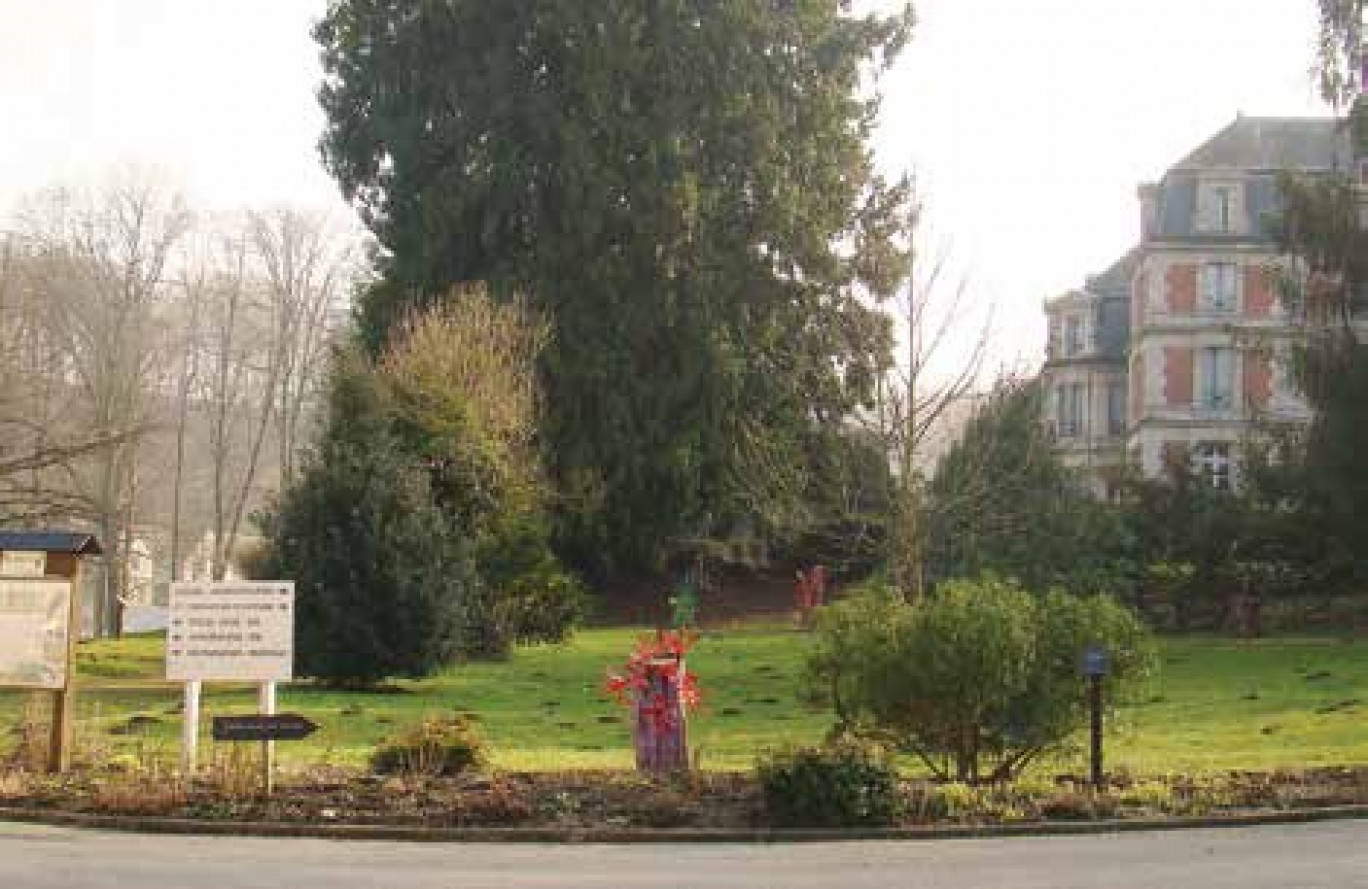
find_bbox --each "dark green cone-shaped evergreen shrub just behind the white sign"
[257,360,480,687]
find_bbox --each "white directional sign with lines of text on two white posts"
[167,580,294,793]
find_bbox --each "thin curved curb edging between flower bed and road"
[0,804,1368,844]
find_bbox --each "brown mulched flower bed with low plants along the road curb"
[0,767,1368,829]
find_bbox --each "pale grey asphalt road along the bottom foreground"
[0,822,1368,889]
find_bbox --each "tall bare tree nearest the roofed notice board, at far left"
[13,171,192,635]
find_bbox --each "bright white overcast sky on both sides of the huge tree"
[0,0,1324,361]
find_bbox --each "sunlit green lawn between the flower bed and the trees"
[0,626,1368,774]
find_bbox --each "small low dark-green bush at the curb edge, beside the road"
[757,744,899,827]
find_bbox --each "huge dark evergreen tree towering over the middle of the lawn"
[315,0,911,570]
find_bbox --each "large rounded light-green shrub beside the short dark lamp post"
[804,577,1155,782]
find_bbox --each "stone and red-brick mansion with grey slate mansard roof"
[1041,116,1353,498]
